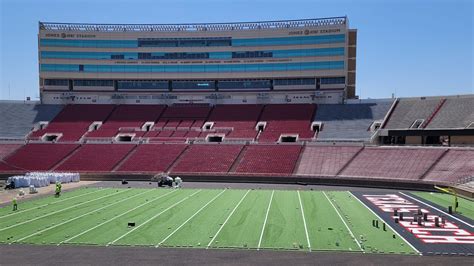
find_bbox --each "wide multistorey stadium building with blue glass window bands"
[38,17,357,104]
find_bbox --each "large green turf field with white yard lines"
[0,188,416,254]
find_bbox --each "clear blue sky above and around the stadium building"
[0,0,474,99]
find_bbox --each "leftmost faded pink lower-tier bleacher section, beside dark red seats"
[296,146,363,176]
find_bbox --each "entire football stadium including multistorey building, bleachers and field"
[0,11,474,265]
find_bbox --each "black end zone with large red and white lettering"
[353,192,474,255]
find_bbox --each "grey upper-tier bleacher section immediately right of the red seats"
[314,101,393,141]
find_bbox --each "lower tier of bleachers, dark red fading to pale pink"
[0,140,474,186]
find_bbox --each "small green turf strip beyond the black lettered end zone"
[413,192,474,220]
